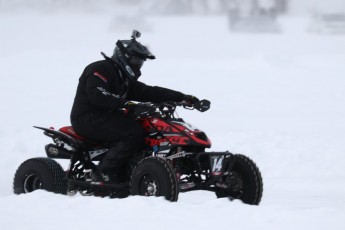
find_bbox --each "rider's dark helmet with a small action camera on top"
[112,30,155,80]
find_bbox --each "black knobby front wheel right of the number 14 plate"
[216,154,263,205]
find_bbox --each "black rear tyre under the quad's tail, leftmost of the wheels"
[13,157,67,194]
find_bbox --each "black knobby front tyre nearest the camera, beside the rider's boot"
[131,157,179,202]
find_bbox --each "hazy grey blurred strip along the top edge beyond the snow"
[0,0,345,15]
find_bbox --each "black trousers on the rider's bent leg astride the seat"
[71,112,145,174]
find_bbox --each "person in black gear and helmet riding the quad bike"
[71,30,198,182]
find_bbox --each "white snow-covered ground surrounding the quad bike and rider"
[0,7,345,230]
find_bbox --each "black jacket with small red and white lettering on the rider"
[71,60,184,121]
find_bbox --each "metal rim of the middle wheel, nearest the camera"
[139,174,160,196]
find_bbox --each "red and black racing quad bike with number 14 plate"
[13,100,263,205]
